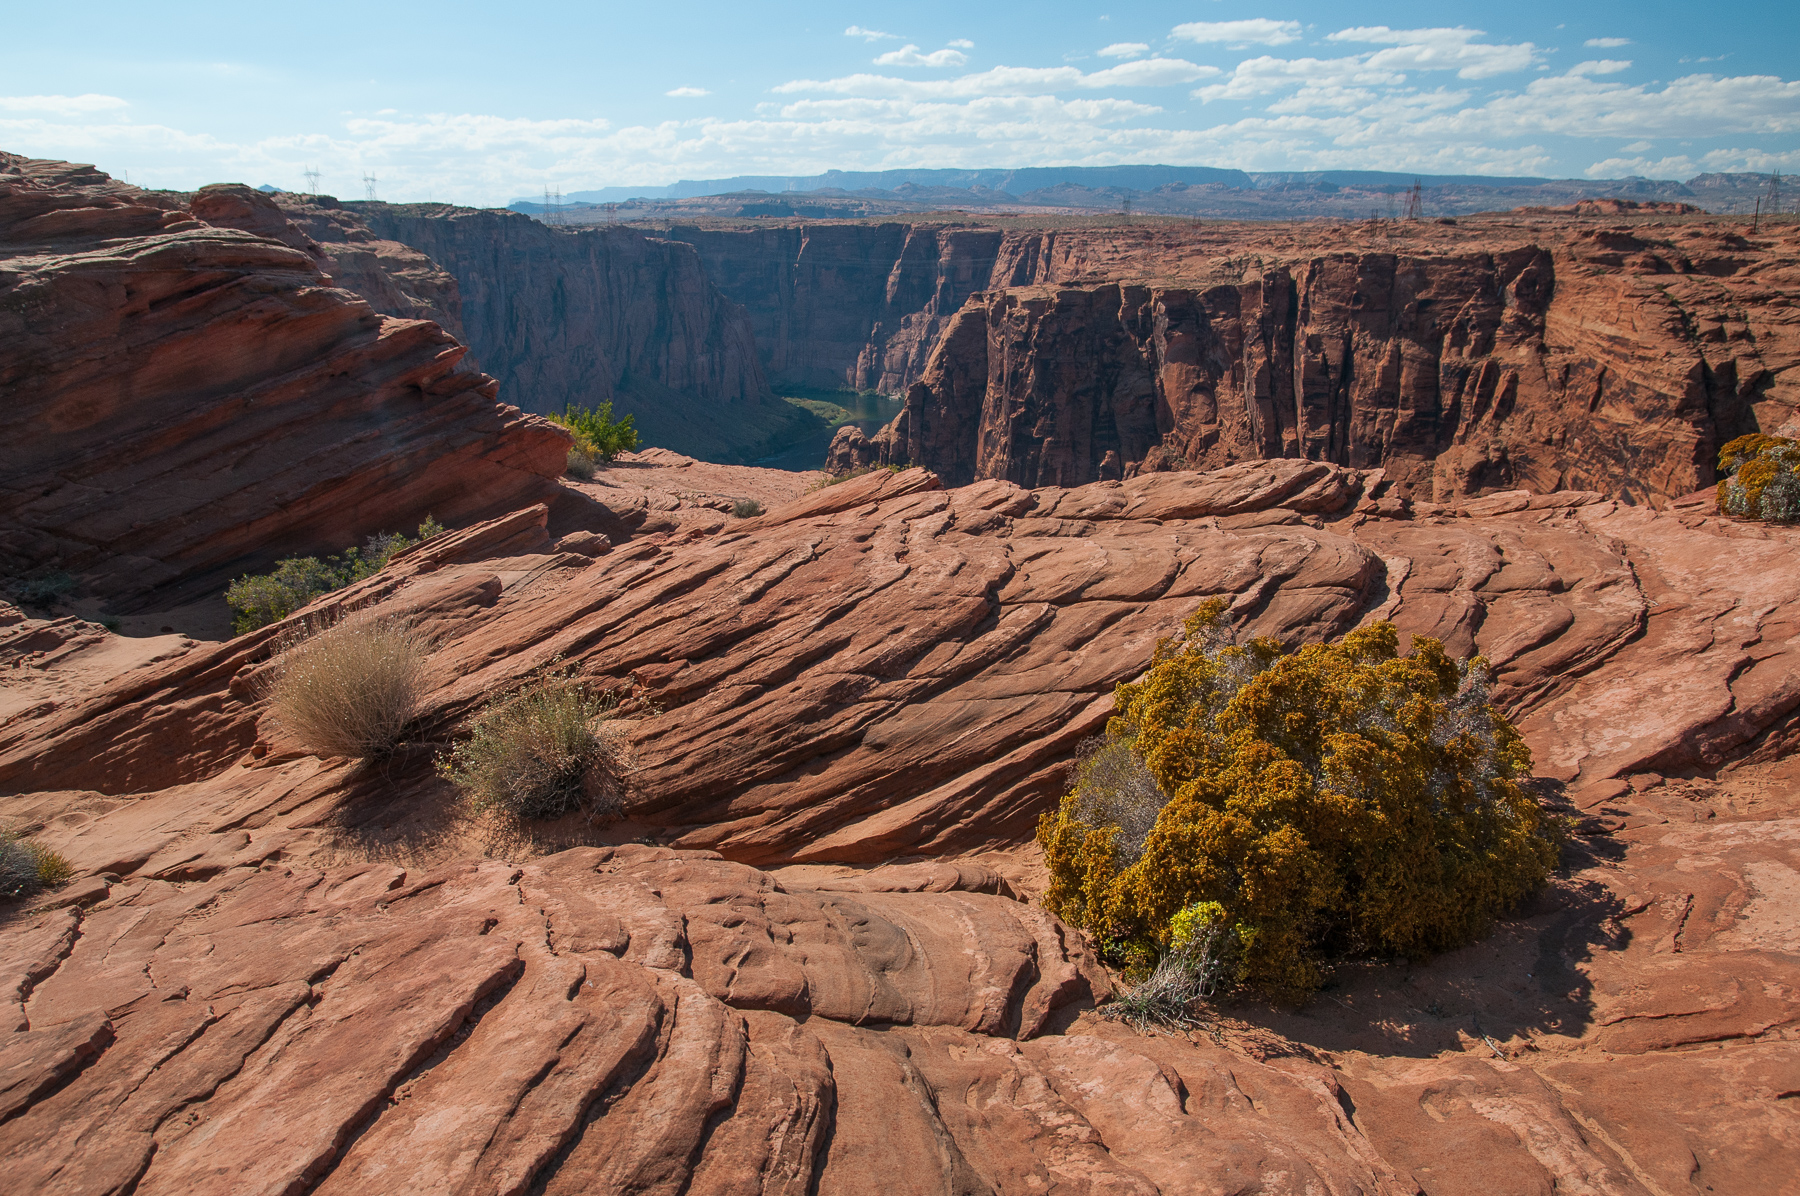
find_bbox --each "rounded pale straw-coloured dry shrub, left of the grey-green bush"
[268,616,430,760]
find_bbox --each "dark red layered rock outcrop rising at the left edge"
[0,155,590,611]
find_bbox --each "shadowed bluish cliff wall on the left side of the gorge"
[344,204,810,459]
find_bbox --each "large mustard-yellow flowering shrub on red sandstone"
[1039,600,1561,994]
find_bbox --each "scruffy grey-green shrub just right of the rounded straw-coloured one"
[437,677,619,818]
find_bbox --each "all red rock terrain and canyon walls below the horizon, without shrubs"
[0,157,1800,1196]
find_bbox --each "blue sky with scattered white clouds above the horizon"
[0,0,1800,204]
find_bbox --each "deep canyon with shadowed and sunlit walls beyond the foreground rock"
[298,192,1800,506]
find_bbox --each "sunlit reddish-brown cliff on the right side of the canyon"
[864,225,1800,504]
